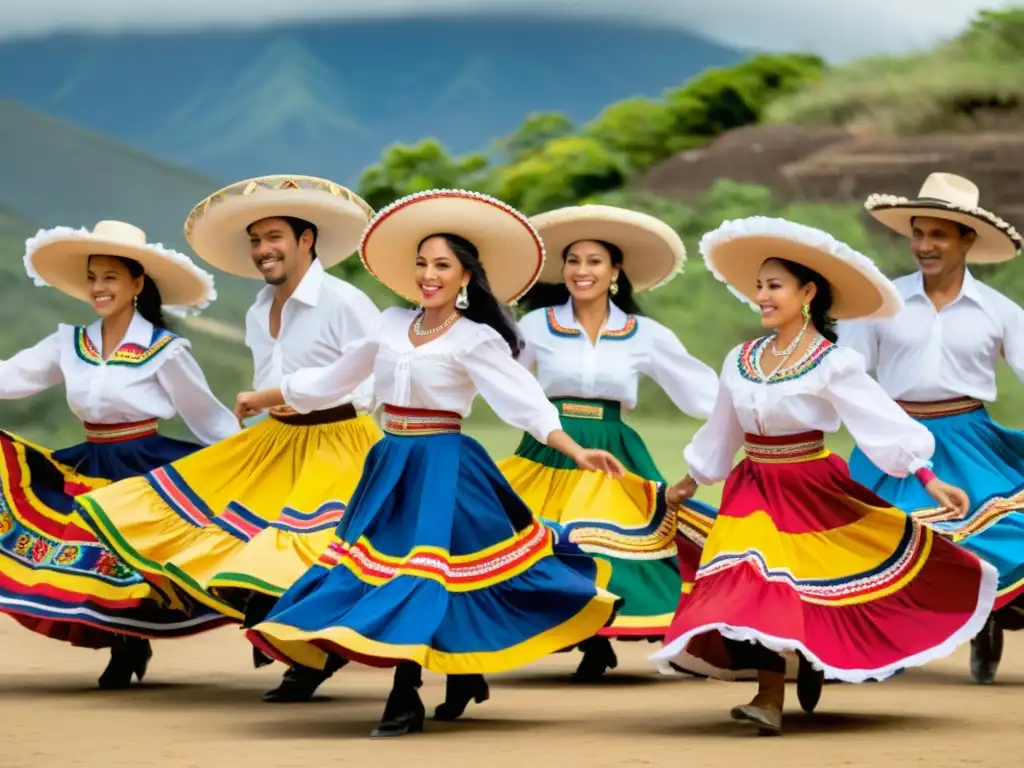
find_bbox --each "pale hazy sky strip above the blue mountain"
[0,0,1019,59]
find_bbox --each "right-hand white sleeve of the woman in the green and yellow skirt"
[640,317,719,420]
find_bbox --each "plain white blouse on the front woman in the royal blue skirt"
[281,307,562,443]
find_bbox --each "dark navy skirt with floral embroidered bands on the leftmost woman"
[0,422,223,648]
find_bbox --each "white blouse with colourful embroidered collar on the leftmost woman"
[0,312,240,445]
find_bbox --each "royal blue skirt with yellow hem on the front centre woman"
[248,432,618,674]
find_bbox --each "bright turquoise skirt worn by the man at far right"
[850,407,1024,629]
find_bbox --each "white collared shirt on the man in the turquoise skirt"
[839,271,1024,402]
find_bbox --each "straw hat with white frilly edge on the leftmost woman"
[25,220,217,309]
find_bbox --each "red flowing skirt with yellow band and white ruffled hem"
[651,432,997,682]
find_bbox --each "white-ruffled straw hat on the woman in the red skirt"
[700,216,903,319]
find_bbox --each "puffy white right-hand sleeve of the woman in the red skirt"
[821,347,935,477]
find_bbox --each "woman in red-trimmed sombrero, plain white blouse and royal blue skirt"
[236,189,624,736]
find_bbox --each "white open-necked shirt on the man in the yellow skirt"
[246,259,380,412]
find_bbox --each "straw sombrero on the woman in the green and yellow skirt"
[530,205,686,292]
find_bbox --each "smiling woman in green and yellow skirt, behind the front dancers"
[498,205,718,680]
